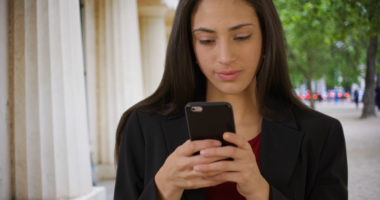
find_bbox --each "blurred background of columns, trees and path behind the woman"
[0,0,380,200]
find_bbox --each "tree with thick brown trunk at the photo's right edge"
[330,0,380,118]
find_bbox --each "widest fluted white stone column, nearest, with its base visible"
[10,0,105,199]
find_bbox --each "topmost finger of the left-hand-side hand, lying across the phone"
[176,139,222,156]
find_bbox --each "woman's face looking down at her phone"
[191,0,262,94]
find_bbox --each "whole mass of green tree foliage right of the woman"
[274,0,380,114]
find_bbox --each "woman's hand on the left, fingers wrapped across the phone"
[155,140,226,200]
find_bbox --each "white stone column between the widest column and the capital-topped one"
[84,0,143,179]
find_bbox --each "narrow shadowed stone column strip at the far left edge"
[0,0,11,199]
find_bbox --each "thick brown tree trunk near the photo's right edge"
[360,35,378,118]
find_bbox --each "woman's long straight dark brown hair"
[115,0,305,162]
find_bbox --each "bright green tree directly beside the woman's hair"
[275,0,334,108]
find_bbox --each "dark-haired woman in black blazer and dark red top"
[115,0,347,199]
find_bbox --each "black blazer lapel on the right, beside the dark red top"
[260,109,303,186]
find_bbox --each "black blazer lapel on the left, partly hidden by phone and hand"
[162,114,205,200]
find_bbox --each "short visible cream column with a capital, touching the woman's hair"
[139,0,168,96]
